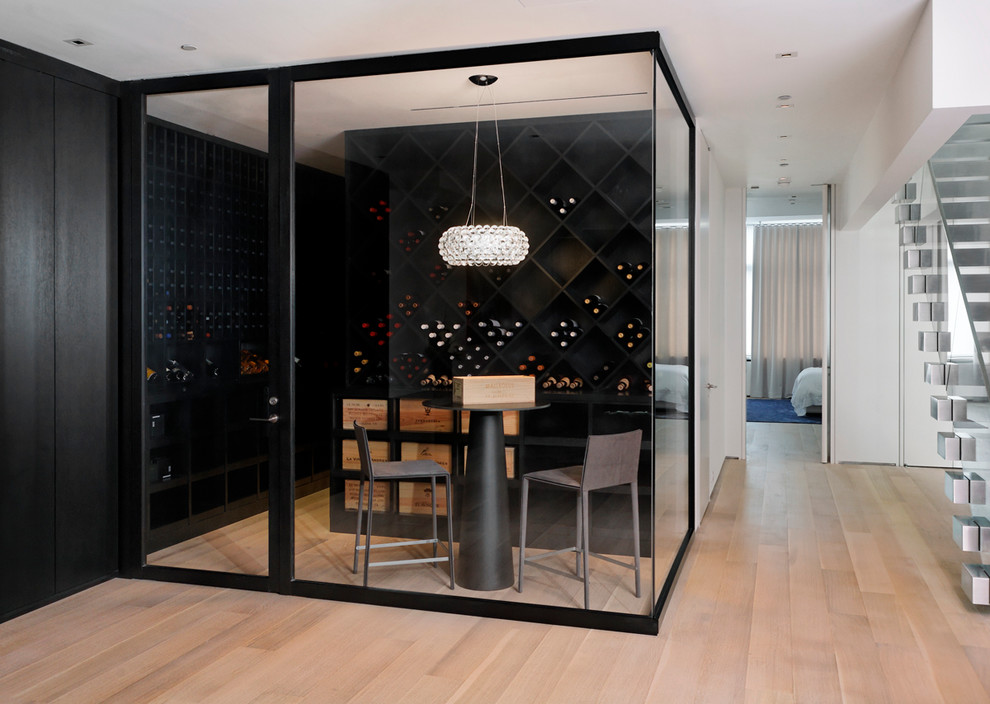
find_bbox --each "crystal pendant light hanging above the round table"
[439,75,529,266]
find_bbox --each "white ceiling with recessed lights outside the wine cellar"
[0,0,927,205]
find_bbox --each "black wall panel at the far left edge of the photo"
[0,62,55,613]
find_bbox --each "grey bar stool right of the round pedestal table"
[519,430,643,609]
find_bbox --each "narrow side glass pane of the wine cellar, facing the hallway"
[653,63,693,582]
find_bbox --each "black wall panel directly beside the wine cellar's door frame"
[54,81,117,592]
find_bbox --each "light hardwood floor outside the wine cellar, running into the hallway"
[0,424,990,704]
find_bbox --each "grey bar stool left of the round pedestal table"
[354,421,454,589]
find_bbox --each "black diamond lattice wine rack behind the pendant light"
[346,112,653,394]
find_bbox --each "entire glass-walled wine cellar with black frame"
[130,35,693,632]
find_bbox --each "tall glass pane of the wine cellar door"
[143,87,269,574]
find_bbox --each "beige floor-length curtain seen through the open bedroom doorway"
[747,224,825,398]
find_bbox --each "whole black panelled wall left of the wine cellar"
[0,61,117,619]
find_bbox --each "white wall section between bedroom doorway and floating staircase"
[832,197,901,464]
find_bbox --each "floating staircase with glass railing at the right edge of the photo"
[919,115,990,605]
